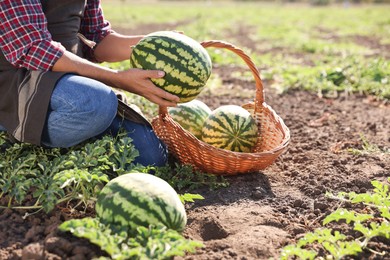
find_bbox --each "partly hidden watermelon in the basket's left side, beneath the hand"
[168,99,211,139]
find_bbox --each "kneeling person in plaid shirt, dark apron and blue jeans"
[0,0,179,166]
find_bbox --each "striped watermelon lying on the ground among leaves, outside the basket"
[95,173,187,231]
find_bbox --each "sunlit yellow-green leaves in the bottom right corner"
[281,178,390,259]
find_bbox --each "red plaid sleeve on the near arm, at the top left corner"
[0,0,65,71]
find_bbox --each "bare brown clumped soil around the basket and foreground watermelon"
[0,23,390,259]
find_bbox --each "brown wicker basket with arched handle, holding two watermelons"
[152,41,290,175]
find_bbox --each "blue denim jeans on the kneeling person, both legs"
[0,74,168,166]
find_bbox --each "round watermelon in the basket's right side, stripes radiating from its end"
[202,105,258,152]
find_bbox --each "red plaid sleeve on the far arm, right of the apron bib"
[80,0,113,61]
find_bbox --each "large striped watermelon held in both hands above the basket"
[130,31,212,103]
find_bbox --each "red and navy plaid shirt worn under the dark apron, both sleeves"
[0,0,111,71]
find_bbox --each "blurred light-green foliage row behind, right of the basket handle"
[267,57,390,99]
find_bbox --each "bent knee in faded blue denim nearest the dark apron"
[42,74,118,147]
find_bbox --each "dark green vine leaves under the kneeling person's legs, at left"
[0,134,138,212]
